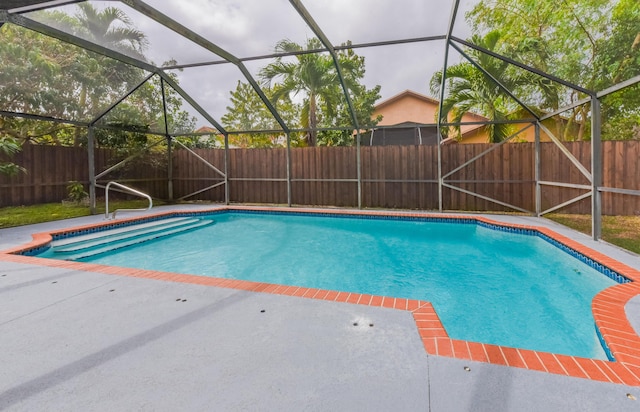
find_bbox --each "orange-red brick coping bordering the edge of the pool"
[0,206,640,386]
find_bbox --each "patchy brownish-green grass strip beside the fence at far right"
[545,213,640,254]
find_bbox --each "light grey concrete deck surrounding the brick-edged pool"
[0,206,640,411]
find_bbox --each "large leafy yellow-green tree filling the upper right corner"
[466,0,640,140]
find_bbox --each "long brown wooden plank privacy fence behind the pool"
[0,141,640,215]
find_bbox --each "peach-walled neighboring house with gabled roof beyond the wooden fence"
[362,90,560,146]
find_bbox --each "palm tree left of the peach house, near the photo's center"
[259,38,341,146]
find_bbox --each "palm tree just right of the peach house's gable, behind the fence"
[430,31,531,143]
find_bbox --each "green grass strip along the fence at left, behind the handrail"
[0,200,162,228]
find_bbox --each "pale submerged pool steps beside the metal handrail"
[51,217,214,260]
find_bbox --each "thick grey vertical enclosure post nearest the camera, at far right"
[591,95,602,240]
